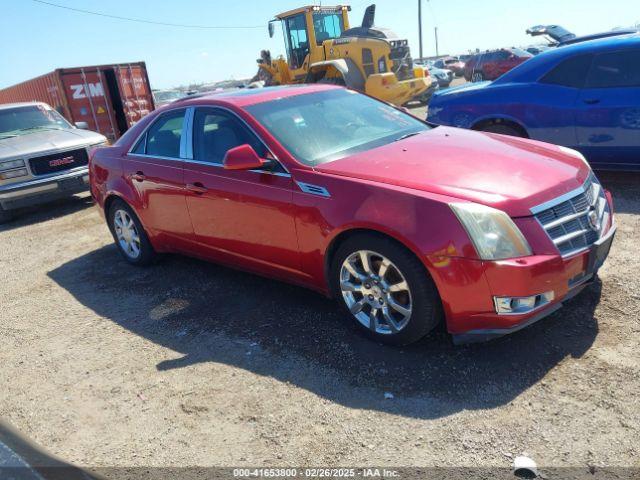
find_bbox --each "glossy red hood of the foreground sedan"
[316,127,590,217]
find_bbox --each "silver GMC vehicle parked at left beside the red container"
[0,102,107,223]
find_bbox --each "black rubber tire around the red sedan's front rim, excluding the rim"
[330,233,442,345]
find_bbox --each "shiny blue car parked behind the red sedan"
[427,34,640,171]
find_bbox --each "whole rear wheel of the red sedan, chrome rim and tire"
[109,201,156,265]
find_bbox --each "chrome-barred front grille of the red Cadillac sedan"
[532,173,611,256]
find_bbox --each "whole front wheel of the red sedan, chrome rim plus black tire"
[333,236,440,345]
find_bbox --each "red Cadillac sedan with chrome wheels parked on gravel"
[90,85,615,344]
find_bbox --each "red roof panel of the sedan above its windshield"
[171,83,341,108]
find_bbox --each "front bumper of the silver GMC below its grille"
[0,167,89,210]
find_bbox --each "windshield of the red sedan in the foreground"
[246,89,430,166]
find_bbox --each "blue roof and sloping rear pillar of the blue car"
[493,34,640,84]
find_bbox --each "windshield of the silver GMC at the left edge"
[0,104,72,138]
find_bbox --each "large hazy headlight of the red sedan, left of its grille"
[449,203,531,260]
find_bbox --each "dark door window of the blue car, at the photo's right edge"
[587,50,640,88]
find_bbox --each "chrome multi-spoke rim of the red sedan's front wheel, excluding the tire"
[340,250,412,335]
